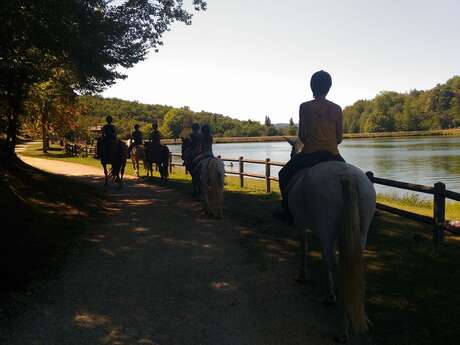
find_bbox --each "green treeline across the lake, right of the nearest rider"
[344,76,460,133]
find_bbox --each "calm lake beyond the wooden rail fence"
[170,136,460,194]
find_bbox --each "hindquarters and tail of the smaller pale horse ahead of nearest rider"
[199,157,225,217]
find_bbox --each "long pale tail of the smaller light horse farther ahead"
[208,158,225,217]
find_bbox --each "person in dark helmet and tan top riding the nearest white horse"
[274,70,345,224]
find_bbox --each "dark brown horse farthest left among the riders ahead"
[98,139,128,188]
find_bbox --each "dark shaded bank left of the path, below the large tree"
[0,152,105,310]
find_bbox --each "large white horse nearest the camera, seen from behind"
[288,162,376,341]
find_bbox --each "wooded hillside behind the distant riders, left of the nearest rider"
[78,96,297,138]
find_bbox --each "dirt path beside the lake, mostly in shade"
[0,153,342,345]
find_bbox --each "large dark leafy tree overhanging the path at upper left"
[0,0,206,154]
